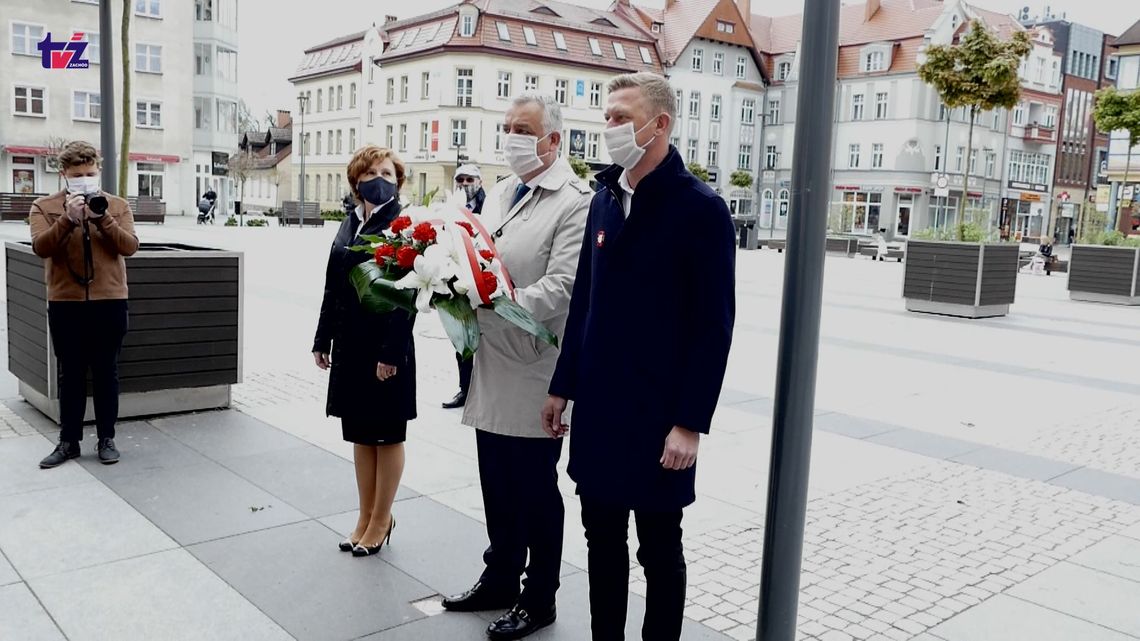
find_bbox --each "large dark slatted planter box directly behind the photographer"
[5,242,243,422]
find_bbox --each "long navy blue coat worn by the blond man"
[549,147,736,510]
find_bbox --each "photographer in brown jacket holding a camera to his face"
[29,140,139,468]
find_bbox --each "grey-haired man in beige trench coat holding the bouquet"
[443,94,593,640]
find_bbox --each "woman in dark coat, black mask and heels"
[312,145,416,557]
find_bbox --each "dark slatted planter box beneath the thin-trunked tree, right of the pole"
[903,241,1018,318]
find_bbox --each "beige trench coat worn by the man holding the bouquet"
[463,157,593,438]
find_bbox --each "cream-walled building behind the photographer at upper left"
[0,0,195,214]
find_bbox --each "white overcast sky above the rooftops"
[238,0,1140,117]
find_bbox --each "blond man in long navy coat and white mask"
[543,73,735,641]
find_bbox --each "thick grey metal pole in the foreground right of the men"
[756,0,839,641]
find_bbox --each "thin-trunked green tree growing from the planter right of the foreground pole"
[918,21,1033,240]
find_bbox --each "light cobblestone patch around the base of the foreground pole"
[661,462,1140,641]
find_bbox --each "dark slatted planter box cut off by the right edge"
[1069,245,1140,305]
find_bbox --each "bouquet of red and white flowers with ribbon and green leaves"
[350,192,559,358]
